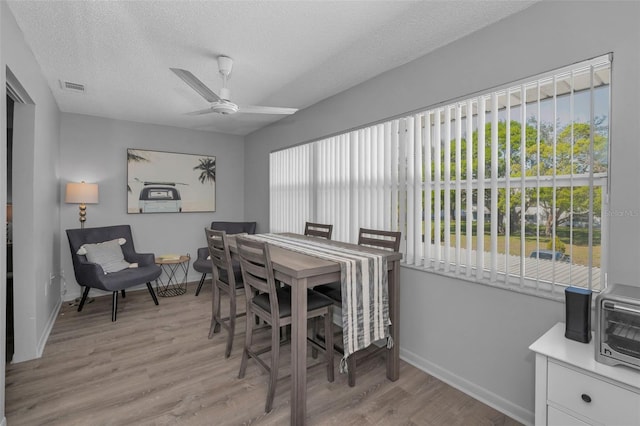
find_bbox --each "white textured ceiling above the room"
[8,0,535,135]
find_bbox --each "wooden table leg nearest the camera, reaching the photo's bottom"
[291,279,307,426]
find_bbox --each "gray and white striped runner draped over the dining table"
[243,234,393,372]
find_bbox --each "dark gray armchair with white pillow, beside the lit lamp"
[67,225,162,321]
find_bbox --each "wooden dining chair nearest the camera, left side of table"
[236,237,334,413]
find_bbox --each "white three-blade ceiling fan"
[170,56,298,115]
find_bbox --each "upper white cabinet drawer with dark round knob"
[547,361,640,426]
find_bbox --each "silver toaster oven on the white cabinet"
[594,284,640,369]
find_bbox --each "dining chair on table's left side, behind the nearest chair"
[204,228,245,358]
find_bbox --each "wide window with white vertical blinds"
[270,56,611,294]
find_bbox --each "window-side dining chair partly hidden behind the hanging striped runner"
[312,228,402,387]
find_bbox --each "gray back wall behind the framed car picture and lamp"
[60,113,244,302]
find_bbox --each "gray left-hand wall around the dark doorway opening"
[0,2,60,362]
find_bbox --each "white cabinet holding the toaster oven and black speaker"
[529,323,640,426]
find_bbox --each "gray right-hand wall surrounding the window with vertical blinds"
[245,1,640,423]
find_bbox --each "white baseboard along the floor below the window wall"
[400,348,535,425]
